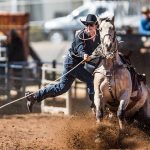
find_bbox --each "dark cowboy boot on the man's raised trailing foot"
[25,91,37,112]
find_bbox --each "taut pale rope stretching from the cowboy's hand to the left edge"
[0,60,85,109]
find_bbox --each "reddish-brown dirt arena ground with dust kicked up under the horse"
[0,89,150,150]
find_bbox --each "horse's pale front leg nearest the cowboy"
[94,73,104,122]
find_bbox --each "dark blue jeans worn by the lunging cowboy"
[35,56,94,102]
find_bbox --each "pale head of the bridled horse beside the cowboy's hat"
[99,16,116,59]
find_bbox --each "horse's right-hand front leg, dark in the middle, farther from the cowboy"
[117,90,130,129]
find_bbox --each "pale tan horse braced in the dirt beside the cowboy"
[93,17,150,129]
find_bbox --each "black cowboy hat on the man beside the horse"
[81,14,97,26]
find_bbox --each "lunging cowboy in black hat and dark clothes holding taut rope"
[25,14,100,112]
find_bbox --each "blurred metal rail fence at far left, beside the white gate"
[0,62,41,100]
